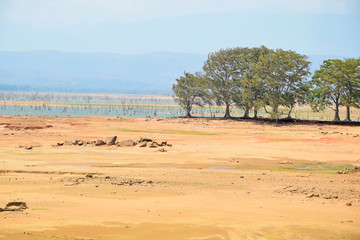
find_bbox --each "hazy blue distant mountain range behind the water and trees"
[0,51,341,94]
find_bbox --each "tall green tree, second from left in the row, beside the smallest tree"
[203,49,236,118]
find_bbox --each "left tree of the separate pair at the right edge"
[309,59,344,121]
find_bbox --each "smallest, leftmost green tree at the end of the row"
[172,72,206,117]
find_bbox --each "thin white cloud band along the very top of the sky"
[0,0,360,27]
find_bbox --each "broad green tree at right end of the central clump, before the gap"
[258,49,310,119]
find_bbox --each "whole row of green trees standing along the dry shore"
[172,46,360,121]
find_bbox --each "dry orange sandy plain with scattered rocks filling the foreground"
[0,116,360,240]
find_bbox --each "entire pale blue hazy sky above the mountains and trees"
[0,0,360,57]
